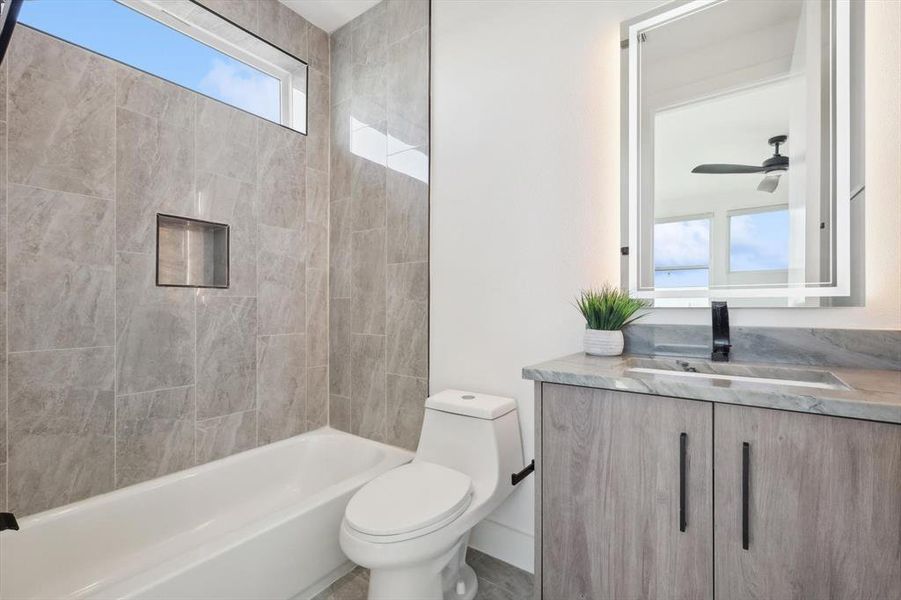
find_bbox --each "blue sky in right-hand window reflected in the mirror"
[729,208,789,271]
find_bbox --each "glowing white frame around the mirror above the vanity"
[620,0,863,307]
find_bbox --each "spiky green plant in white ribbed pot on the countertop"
[576,284,651,356]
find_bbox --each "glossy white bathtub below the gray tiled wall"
[0,428,413,600]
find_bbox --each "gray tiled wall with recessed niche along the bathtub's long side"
[0,0,330,516]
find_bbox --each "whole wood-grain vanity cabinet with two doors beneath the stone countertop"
[536,383,901,600]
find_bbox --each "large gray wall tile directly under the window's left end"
[8,27,116,198]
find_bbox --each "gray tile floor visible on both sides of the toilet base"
[313,548,532,600]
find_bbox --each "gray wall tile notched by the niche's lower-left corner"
[116,252,194,395]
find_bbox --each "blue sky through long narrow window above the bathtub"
[19,0,281,123]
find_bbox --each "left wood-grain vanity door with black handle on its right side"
[541,384,713,600]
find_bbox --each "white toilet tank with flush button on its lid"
[415,390,523,494]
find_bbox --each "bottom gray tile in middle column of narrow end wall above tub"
[350,334,386,442]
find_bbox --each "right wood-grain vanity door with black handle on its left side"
[714,405,901,600]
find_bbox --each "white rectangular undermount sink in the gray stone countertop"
[626,358,851,390]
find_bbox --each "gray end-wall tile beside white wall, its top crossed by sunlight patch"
[388,149,429,262]
